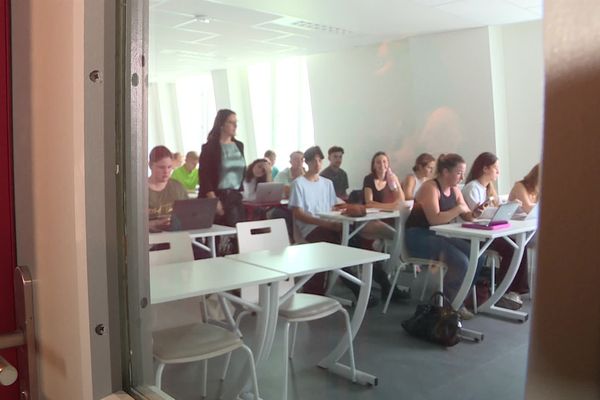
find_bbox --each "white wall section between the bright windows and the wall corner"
[308,42,413,189]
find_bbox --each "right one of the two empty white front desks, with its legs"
[225,242,389,385]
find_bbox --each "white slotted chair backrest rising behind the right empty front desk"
[235,218,290,253]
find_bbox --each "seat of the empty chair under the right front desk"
[279,293,342,320]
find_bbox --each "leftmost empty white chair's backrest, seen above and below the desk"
[149,232,202,331]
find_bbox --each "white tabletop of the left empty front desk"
[150,257,287,304]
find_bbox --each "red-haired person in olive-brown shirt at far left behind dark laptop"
[148,146,187,232]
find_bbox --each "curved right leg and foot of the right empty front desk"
[319,264,377,386]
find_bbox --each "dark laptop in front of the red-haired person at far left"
[166,198,219,231]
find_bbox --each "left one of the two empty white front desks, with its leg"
[150,257,287,398]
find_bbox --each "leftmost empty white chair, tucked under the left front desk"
[149,232,259,399]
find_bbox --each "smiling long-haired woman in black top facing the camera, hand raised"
[360,151,410,301]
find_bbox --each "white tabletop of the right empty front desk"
[225,242,390,277]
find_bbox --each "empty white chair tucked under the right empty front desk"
[236,219,356,399]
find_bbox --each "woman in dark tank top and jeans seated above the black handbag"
[405,154,483,319]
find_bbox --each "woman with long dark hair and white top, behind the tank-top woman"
[462,152,527,310]
